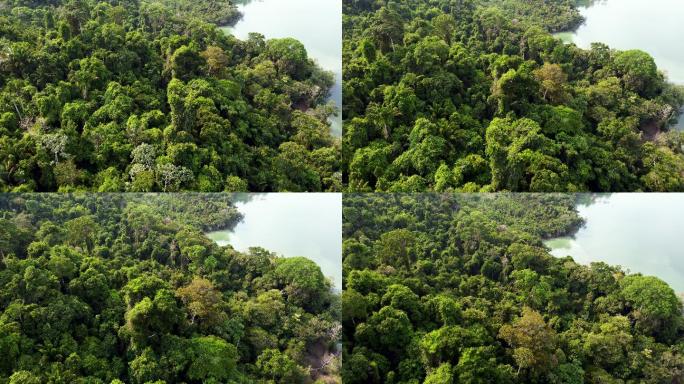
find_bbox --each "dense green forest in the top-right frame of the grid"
[342,0,684,192]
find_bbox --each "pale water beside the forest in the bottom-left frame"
[206,193,342,289]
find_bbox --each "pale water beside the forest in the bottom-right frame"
[545,193,684,293]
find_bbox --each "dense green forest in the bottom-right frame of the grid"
[342,193,684,384]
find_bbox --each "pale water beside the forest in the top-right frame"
[557,0,684,130]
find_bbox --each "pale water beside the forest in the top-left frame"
[224,0,342,137]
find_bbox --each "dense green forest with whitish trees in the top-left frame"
[0,0,342,192]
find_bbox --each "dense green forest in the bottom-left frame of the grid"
[0,193,341,384]
